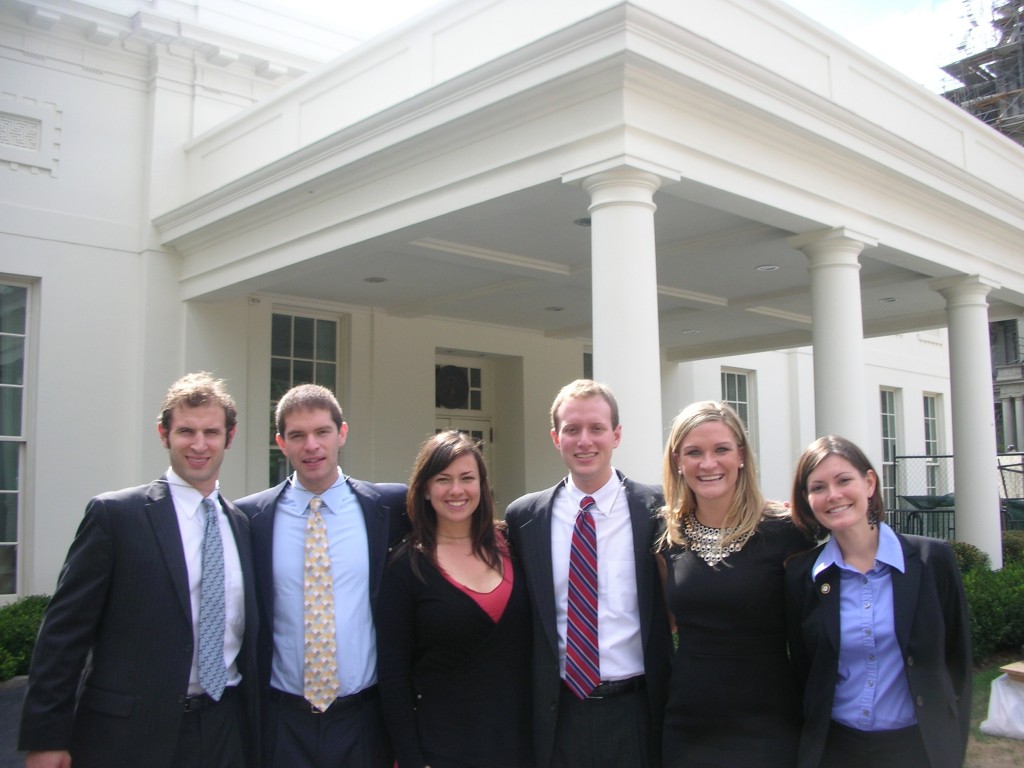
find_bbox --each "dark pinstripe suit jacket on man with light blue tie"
[18,478,258,768]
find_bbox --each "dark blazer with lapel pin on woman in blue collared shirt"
[785,534,972,768]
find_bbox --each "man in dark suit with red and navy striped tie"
[506,379,672,768]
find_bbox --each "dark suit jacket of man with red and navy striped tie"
[505,478,672,768]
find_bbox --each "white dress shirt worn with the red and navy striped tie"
[551,471,644,680]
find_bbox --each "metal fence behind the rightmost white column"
[886,453,1024,541]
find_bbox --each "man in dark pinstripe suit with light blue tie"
[18,373,257,768]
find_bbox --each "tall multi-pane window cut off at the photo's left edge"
[0,285,29,595]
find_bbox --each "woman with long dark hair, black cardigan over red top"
[377,430,532,768]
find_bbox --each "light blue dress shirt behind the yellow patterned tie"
[270,469,377,696]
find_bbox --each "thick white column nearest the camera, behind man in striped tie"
[583,167,665,482]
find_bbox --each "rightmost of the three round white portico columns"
[931,275,1002,568]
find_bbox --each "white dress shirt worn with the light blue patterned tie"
[167,469,246,696]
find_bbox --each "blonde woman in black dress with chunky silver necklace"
[659,401,811,768]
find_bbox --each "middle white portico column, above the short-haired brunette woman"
[790,228,878,444]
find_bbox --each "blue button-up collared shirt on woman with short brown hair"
[811,523,918,731]
